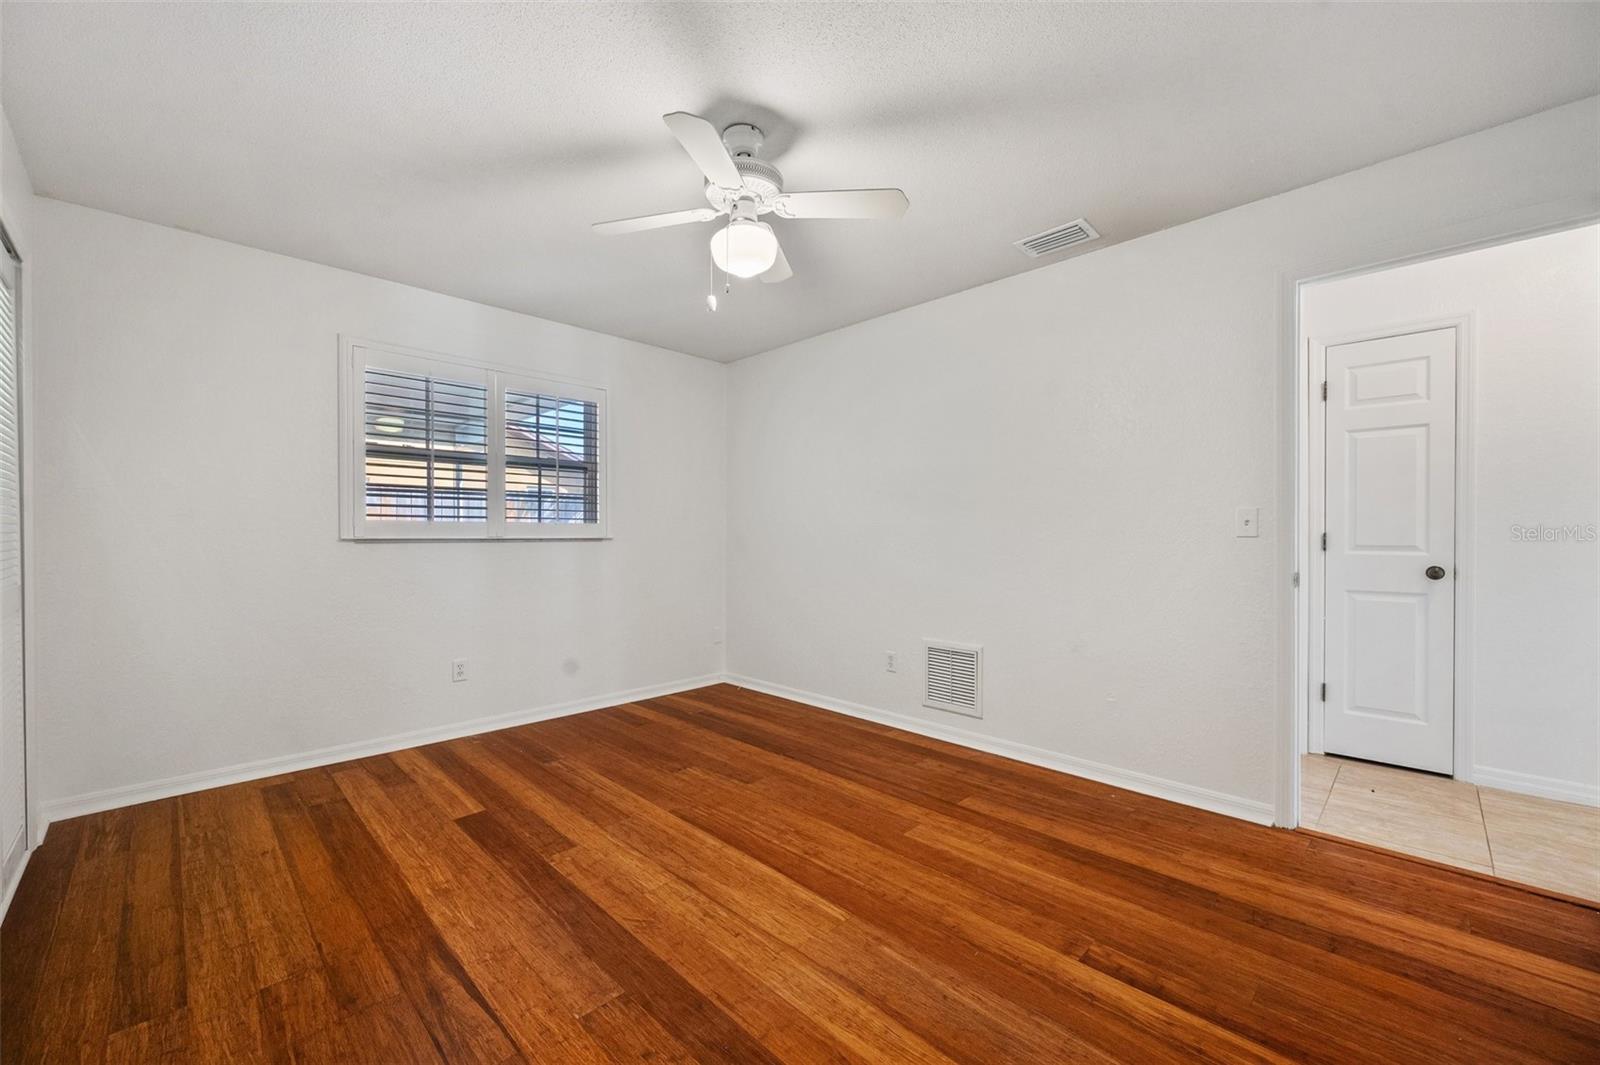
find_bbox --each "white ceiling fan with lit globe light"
[594,110,909,283]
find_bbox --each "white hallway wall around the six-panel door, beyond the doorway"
[1301,225,1600,801]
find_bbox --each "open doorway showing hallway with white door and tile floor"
[1299,225,1600,900]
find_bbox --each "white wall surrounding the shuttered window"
[30,198,725,816]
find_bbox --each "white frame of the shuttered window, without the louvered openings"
[339,336,611,540]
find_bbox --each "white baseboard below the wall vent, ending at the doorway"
[723,673,1272,825]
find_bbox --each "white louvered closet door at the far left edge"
[0,251,27,875]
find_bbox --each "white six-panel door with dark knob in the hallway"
[1323,328,1456,772]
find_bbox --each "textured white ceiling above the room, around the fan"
[0,3,1600,360]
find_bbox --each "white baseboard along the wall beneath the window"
[38,675,722,840]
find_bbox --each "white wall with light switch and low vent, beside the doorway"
[728,99,1600,817]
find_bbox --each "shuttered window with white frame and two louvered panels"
[341,339,608,540]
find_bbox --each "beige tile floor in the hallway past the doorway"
[1301,755,1600,902]
